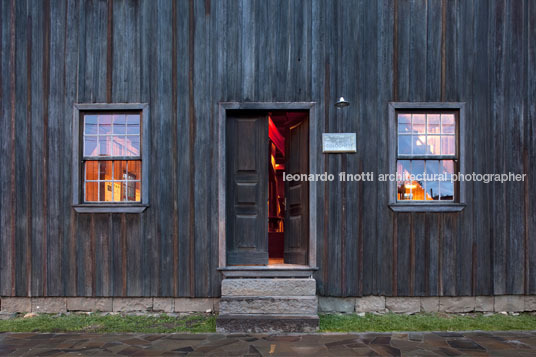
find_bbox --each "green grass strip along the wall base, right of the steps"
[320,313,536,332]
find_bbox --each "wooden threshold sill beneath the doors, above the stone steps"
[218,264,318,278]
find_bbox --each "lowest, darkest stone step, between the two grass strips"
[216,314,318,333]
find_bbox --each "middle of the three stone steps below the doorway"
[220,296,318,315]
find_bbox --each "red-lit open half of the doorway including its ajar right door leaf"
[268,111,309,265]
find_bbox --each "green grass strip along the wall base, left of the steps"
[0,314,216,333]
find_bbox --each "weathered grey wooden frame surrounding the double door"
[217,102,320,271]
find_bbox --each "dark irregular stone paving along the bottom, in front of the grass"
[0,331,536,356]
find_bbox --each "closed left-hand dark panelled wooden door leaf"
[226,113,269,265]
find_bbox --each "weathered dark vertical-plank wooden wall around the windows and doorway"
[0,0,536,296]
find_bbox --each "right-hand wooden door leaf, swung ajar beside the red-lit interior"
[284,120,309,265]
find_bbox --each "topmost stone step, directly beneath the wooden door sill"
[221,279,316,296]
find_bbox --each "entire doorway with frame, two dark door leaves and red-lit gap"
[218,103,316,268]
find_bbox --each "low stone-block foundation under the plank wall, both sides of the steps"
[0,295,536,314]
